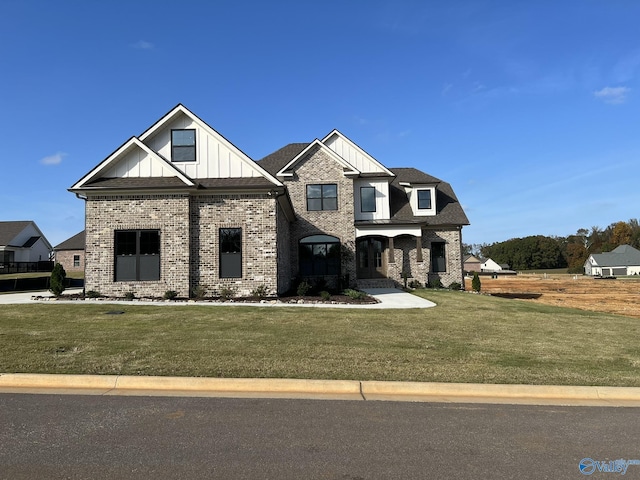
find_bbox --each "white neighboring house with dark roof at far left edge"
[0,220,52,273]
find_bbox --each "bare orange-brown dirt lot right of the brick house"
[465,274,640,318]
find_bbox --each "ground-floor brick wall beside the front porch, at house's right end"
[385,228,464,287]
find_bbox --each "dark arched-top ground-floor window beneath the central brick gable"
[299,235,340,276]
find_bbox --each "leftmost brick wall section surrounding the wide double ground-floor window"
[85,194,189,297]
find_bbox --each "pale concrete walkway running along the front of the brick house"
[0,288,436,309]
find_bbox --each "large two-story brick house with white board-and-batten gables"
[69,105,469,296]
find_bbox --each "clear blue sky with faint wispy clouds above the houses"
[0,0,640,245]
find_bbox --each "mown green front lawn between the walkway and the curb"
[0,290,640,386]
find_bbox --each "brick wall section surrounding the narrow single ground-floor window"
[190,194,278,296]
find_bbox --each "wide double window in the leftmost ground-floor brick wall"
[114,230,160,282]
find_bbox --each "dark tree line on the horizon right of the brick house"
[463,218,640,273]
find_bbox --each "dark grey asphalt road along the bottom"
[0,394,640,480]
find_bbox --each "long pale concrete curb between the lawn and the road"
[0,373,640,406]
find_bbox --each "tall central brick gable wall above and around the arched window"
[285,148,356,287]
